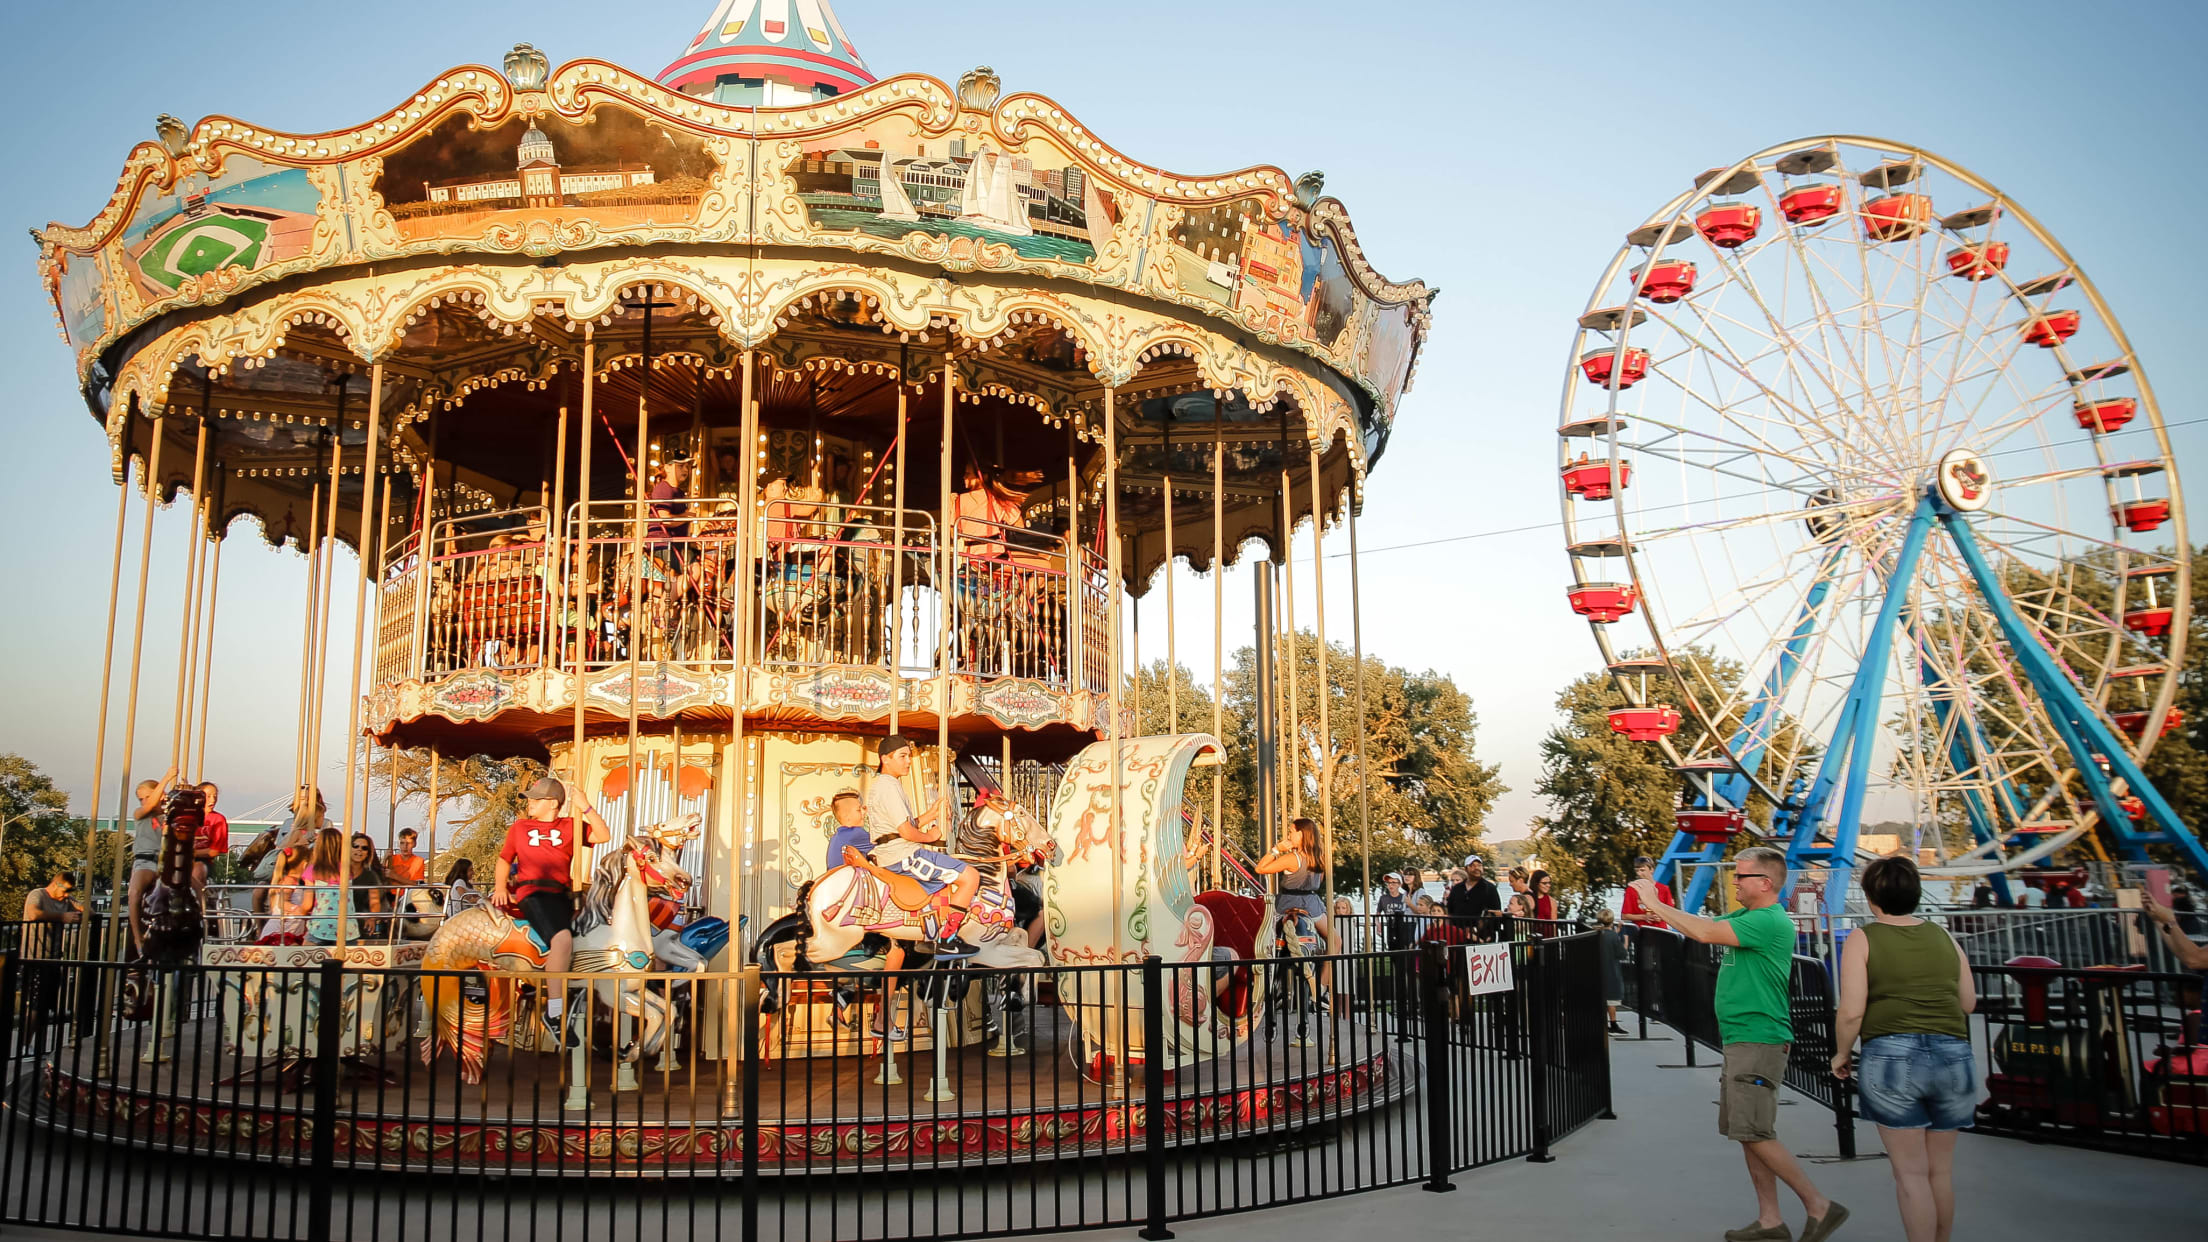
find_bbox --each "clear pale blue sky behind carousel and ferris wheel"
[0,0,2208,838]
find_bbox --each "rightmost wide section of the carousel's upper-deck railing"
[952,517,1075,690]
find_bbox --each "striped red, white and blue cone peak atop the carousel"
[658,0,874,104]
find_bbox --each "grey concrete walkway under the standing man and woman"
[1051,1036,2208,1242]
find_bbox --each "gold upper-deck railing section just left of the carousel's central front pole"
[554,499,744,670]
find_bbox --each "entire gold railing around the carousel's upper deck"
[375,490,1108,696]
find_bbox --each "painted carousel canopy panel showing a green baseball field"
[121,155,322,298]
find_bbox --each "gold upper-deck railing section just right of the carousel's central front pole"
[755,499,943,676]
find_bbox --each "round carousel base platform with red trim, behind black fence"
[13,1006,1415,1178]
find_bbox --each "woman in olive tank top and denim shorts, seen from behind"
[1833,855,1978,1242]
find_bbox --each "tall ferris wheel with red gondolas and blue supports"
[1559,137,2208,913]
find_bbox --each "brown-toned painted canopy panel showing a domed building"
[375,106,720,241]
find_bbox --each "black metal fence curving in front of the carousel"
[0,935,1610,1242]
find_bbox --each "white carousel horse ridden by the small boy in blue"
[751,769,1042,1043]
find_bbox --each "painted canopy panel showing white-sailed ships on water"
[788,117,1119,263]
